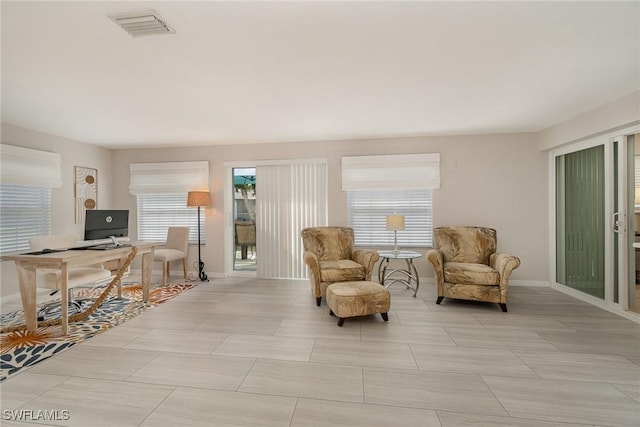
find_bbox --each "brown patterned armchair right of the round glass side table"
[427,227,520,312]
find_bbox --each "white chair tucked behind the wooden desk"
[29,234,111,318]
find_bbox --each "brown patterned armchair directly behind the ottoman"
[301,227,380,306]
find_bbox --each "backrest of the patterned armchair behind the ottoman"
[301,226,354,261]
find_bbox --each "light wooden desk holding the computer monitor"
[2,242,160,335]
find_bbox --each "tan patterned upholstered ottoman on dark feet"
[326,281,391,326]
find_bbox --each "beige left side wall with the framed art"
[0,123,113,295]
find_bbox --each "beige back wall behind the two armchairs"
[113,134,549,282]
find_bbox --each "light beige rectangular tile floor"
[0,278,640,427]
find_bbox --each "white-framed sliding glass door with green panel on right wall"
[552,136,633,309]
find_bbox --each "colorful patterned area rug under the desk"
[0,284,196,382]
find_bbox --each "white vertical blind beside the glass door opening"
[256,161,327,279]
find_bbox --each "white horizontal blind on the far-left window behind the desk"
[0,184,51,253]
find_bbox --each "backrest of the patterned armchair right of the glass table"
[433,226,497,264]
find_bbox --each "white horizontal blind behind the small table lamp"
[347,189,433,248]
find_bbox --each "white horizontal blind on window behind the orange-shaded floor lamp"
[137,193,207,245]
